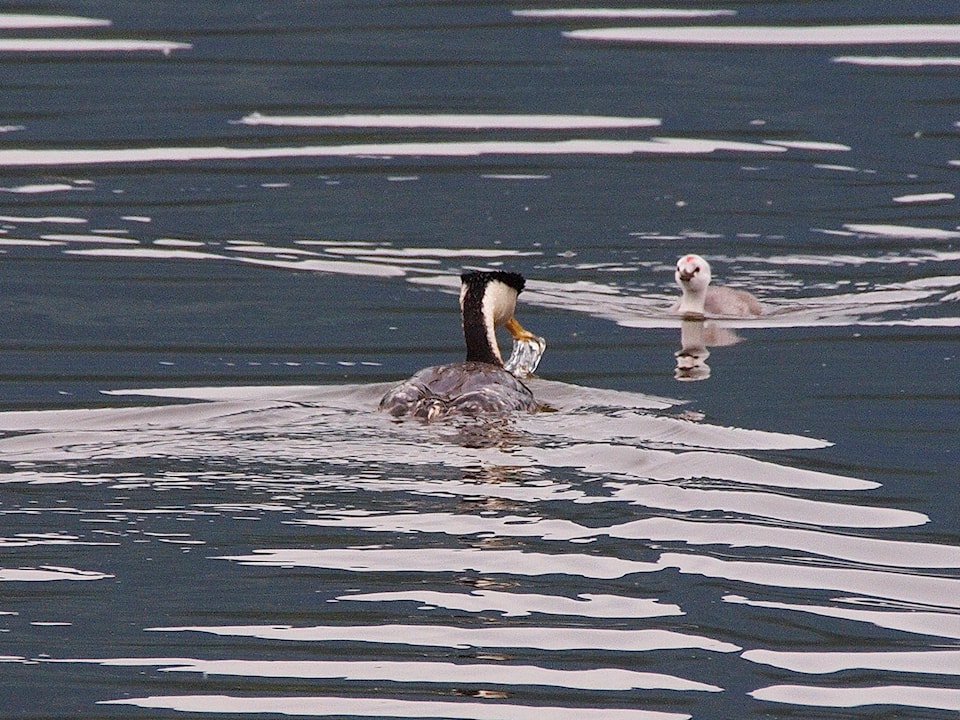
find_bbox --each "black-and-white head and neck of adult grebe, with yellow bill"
[460,270,534,367]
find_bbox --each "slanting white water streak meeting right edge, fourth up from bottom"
[658,553,960,609]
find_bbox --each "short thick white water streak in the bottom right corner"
[748,685,960,710]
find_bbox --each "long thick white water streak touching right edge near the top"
[564,24,960,45]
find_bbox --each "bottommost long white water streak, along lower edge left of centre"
[105,694,690,720]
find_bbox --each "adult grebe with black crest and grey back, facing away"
[380,271,542,420]
